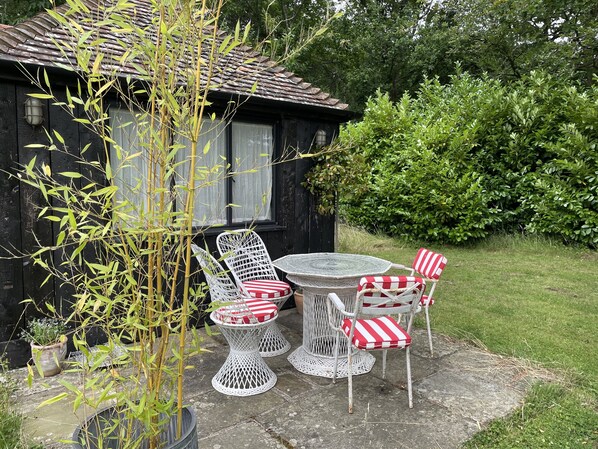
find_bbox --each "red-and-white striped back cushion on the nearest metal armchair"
[357,276,426,308]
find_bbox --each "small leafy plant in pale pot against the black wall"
[21,317,67,377]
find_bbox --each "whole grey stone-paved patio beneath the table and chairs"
[11,309,548,449]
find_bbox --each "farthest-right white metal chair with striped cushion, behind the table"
[392,248,447,355]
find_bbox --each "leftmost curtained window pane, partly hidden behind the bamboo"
[110,109,148,216]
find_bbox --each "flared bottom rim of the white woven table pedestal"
[287,346,376,379]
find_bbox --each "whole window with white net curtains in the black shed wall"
[111,109,274,226]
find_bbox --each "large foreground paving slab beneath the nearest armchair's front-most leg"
[256,375,477,449]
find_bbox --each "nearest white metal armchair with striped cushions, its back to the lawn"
[327,276,426,413]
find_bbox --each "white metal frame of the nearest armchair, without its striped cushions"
[326,282,425,413]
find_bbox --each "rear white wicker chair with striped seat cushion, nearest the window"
[216,229,293,357]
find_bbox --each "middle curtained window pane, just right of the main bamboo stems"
[177,118,226,226]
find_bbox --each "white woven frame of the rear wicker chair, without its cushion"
[216,229,293,357]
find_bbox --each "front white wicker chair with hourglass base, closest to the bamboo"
[192,245,278,396]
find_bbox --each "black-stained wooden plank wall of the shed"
[0,79,338,366]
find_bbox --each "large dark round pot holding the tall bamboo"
[72,407,199,449]
